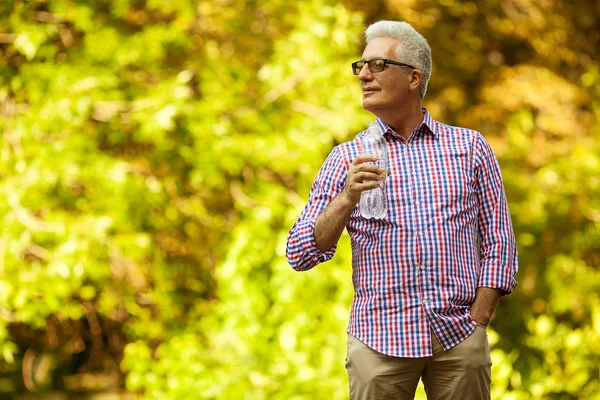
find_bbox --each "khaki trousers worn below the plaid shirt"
[346,325,492,400]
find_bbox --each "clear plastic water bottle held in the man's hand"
[360,122,388,219]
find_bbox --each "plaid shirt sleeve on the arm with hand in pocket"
[475,134,519,295]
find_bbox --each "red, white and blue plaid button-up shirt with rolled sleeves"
[287,109,518,357]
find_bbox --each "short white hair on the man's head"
[365,21,431,98]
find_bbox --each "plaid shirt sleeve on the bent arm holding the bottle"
[286,147,348,271]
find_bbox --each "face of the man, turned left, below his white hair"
[358,38,410,115]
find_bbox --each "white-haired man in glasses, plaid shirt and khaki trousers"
[287,21,518,400]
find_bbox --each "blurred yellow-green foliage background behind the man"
[0,0,600,400]
